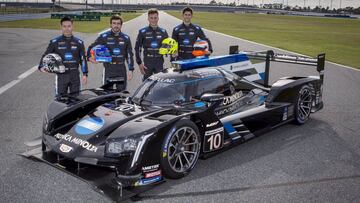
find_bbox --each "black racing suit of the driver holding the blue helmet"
[87,30,134,91]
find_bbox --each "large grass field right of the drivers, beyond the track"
[168,12,360,69]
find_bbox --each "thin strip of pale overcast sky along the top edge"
[5,0,360,8]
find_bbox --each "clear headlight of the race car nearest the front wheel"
[106,138,138,154]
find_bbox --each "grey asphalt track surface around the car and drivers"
[0,13,360,202]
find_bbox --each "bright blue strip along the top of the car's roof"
[173,54,249,70]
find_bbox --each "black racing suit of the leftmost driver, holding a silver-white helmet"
[38,35,88,96]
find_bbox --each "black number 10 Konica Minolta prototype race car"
[24,47,325,201]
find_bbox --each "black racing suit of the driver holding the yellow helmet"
[135,26,169,80]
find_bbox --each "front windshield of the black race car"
[132,80,195,105]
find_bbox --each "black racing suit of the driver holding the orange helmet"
[172,23,213,60]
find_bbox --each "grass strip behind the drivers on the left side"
[0,13,140,33]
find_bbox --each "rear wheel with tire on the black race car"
[294,85,313,125]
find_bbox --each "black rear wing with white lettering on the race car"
[229,46,325,86]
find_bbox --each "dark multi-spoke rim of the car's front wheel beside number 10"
[168,127,200,173]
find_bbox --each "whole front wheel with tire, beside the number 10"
[160,119,201,179]
